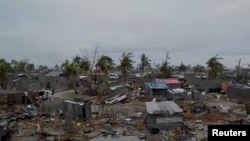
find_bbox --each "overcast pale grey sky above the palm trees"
[0,0,250,68]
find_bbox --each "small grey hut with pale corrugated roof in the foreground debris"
[145,101,183,130]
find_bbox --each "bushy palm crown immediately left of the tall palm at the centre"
[96,55,115,75]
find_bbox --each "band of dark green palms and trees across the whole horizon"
[0,48,250,89]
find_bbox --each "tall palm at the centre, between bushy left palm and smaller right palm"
[119,52,134,79]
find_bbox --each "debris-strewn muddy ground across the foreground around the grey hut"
[0,85,249,141]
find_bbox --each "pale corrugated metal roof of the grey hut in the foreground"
[145,101,182,115]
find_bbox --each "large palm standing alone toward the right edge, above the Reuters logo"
[206,55,225,79]
